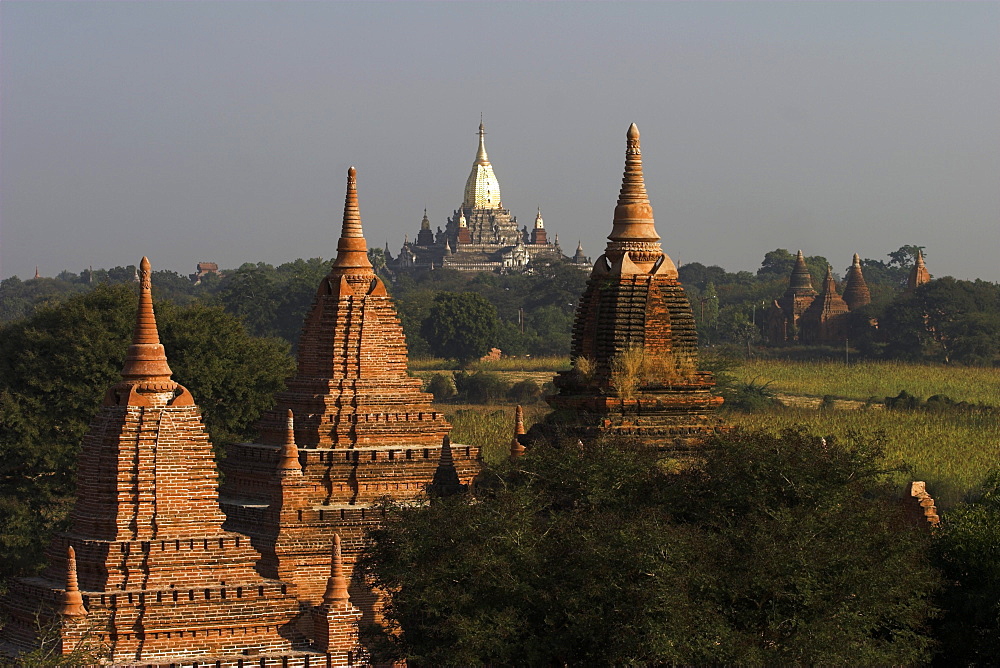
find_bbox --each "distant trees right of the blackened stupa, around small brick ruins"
[679,245,1000,366]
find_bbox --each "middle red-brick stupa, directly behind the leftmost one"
[221,167,479,620]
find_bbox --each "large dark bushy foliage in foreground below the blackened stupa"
[362,431,938,665]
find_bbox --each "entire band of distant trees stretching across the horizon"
[7,245,1000,365]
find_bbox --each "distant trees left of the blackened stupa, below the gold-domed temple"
[0,258,588,359]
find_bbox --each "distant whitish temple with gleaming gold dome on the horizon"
[389,123,589,273]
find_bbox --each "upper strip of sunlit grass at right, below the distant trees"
[731,360,1000,407]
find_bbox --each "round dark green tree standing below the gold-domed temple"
[420,292,499,364]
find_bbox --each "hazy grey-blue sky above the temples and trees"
[0,0,1000,282]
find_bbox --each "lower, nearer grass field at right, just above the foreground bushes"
[726,408,1000,507]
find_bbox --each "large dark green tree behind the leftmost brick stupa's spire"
[0,285,293,579]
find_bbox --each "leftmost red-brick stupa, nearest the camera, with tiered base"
[3,258,336,666]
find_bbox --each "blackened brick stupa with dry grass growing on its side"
[533,123,723,451]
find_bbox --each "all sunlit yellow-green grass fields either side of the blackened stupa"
[424,359,1000,508]
